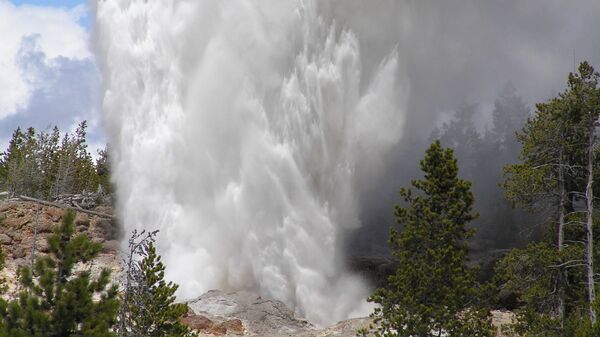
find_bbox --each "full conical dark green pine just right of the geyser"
[369,141,492,337]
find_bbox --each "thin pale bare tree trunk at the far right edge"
[585,128,596,324]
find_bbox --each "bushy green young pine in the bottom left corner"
[0,212,119,337]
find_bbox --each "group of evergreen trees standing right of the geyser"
[360,62,600,337]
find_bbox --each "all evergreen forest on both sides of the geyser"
[0,62,600,337]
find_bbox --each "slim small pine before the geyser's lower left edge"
[123,241,194,337]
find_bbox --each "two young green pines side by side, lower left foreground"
[0,211,195,337]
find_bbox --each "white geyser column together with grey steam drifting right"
[96,0,600,324]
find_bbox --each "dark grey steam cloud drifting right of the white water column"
[330,0,600,255]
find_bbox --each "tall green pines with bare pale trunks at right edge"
[496,62,600,336]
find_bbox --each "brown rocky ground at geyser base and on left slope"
[0,200,513,337]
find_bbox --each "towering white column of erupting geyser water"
[97,0,407,324]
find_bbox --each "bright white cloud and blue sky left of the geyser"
[0,0,103,143]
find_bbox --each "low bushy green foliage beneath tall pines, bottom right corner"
[496,235,600,337]
